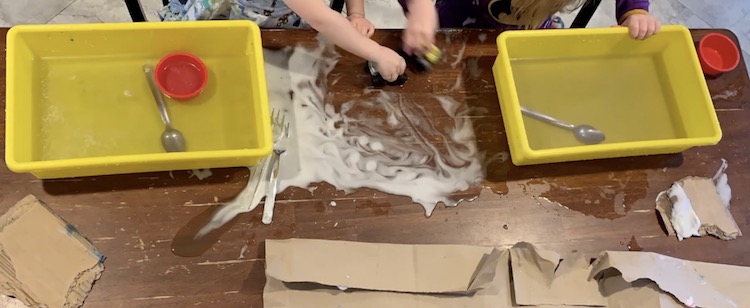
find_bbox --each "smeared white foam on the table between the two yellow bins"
[196,35,484,238]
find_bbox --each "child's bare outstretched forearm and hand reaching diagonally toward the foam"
[284,0,406,81]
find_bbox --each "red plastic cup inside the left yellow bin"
[154,52,208,100]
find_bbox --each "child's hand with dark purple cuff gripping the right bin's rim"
[616,0,661,40]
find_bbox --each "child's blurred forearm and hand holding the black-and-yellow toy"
[399,0,438,55]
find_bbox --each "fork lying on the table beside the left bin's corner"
[261,110,289,224]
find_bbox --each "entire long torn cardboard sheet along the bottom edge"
[263,239,750,308]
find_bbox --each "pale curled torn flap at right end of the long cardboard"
[589,251,735,307]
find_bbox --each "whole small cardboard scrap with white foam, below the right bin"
[656,177,742,240]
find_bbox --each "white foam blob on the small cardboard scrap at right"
[667,183,701,241]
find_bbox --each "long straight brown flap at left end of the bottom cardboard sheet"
[266,240,494,293]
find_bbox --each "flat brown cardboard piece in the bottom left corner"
[0,195,104,307]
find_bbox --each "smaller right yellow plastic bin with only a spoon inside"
[493,25,721,165]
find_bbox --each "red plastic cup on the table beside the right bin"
[698,33,740,76]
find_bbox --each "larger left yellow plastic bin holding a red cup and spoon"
[5,21,272,179]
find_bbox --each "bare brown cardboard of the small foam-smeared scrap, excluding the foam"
[656,177,742,240]
